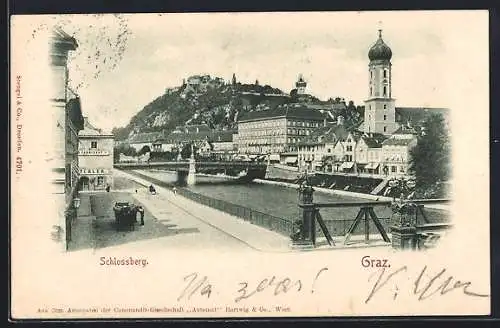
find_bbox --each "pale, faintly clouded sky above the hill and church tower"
[38,11,487,131]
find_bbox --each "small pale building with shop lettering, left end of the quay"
[78,117,114,190]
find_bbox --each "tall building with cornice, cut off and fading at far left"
[47,28,83,250]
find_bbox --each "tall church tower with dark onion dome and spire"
[364,30,398,135]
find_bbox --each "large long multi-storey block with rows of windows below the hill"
[238,106,326,156]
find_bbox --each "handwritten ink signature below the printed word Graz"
[365,265,490,304]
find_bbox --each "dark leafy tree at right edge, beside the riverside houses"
[410,114,451,197]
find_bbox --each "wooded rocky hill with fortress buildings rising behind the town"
[112,75,362,140]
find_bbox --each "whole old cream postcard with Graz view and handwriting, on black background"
[10,11,491,320]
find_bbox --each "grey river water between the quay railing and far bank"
[137,170,448,225]
